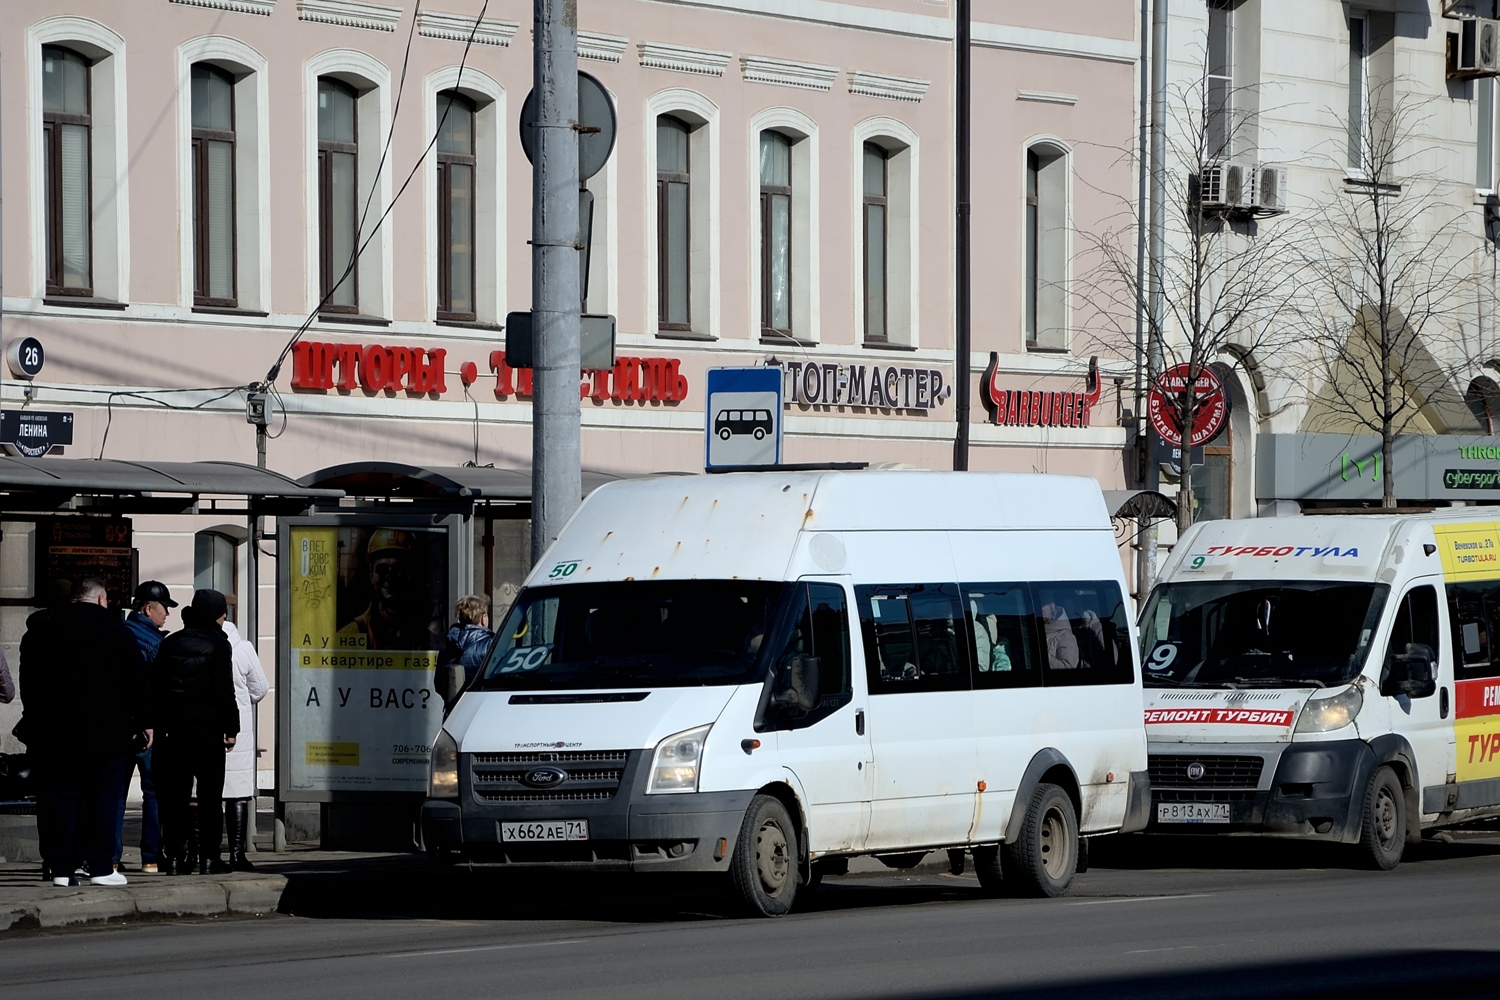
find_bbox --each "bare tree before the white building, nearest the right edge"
[1298,85,1481,507]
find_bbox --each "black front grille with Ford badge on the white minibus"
[468,750,630,802]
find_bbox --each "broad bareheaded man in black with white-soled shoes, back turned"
[18,579,152,886]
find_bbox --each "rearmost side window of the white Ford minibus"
[1032,580,1136,687]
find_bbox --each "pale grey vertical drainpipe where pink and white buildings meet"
[1137,0,1169,600]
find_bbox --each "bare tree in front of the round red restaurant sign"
[1079,64,1304,528]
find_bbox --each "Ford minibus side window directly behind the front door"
[854,583,971,694]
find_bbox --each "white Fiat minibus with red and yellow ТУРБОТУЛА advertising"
[1140,508,1500,870]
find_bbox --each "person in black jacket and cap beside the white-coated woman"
[152,589,240,876]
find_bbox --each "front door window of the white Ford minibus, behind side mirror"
[758,583,854,732]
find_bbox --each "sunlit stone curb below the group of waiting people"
[0,876,287,933]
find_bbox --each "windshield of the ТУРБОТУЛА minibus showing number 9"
[1140,580,1391,688]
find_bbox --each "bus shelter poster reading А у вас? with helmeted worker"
[284,525,449,793]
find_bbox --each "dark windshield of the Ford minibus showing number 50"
[473,580,786,691]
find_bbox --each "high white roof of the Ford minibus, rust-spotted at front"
[540,469,1112,583]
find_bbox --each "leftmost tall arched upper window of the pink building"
[42,45,93,295]
